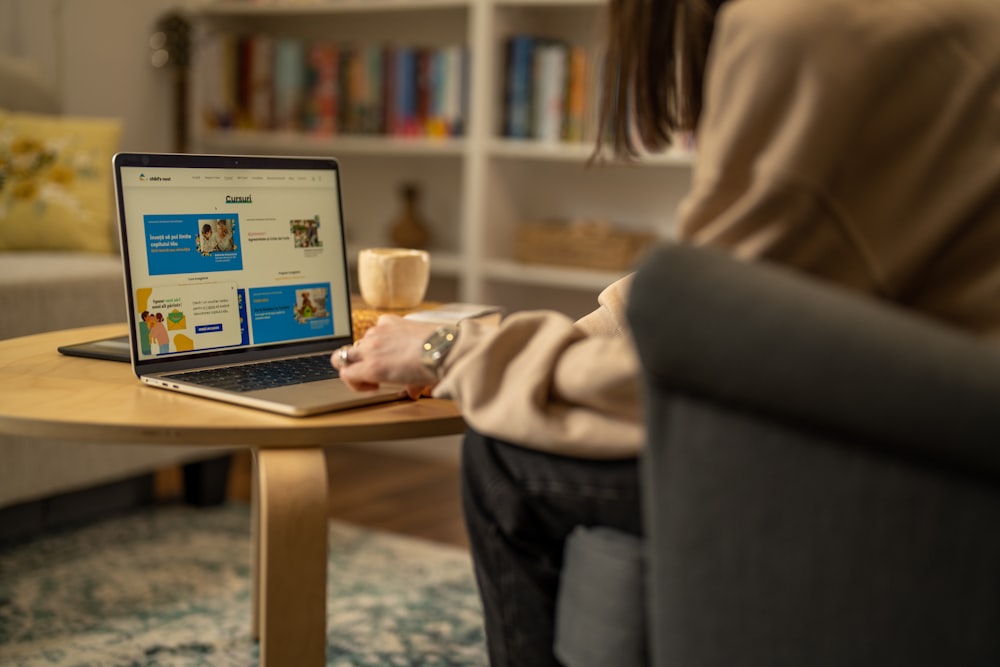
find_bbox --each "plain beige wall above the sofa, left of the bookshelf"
[0,0,188,151]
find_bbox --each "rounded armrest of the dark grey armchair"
[628,246,1000,474]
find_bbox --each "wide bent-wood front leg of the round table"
[252,447,327,667]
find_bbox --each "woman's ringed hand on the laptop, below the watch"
[330,315,437,398]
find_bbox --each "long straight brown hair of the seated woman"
[594,0,726,159]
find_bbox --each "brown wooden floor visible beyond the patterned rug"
[157,446,468,547]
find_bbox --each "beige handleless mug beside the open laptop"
[358,248,431,310]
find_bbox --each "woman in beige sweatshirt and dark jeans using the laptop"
[332,0,1000,666]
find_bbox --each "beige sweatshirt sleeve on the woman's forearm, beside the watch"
[434,279,644,458]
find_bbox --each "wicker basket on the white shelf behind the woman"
[514,220,656,271]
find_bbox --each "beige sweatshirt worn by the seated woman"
[435,0,1000,458]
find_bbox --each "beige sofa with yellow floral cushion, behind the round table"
[0,57,229,539]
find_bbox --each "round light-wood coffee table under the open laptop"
[0,324,465,667]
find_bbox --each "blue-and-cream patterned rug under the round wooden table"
[0,505,487,667]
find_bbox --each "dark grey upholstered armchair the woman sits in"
[556,246,1000,667]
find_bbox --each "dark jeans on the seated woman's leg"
[462,430,642,667]
